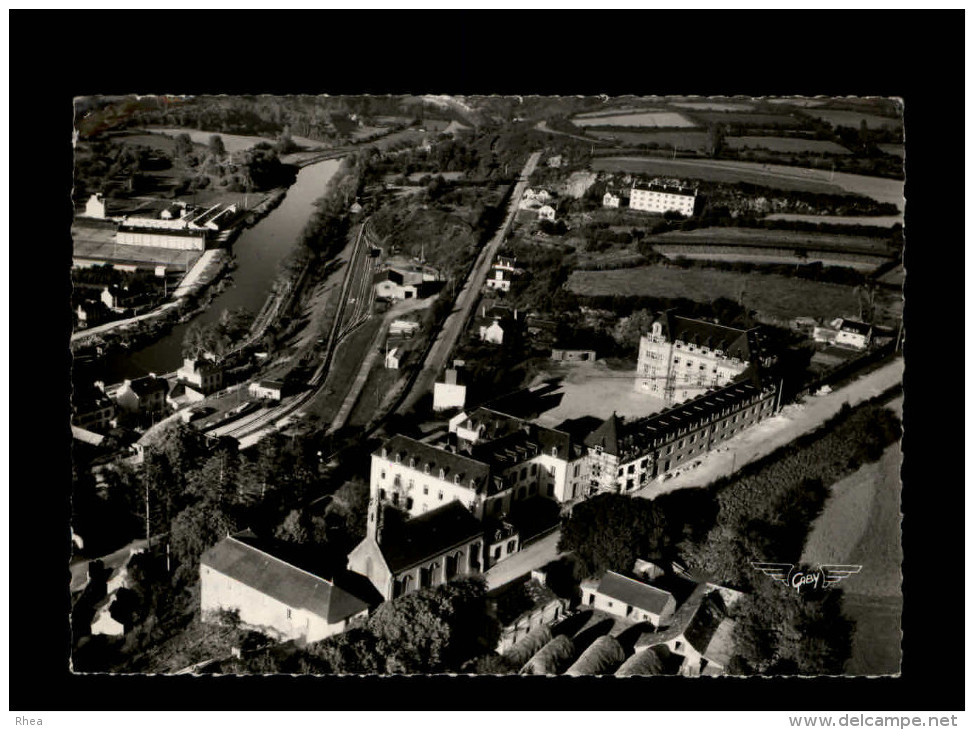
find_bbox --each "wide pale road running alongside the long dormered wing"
[633,358,903,499]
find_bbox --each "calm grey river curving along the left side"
[75,160,341,384]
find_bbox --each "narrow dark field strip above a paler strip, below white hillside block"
[647,228,889,255]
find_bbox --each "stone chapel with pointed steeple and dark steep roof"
[348,499,484,601]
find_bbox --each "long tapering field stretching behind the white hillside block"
[592,157,904,210]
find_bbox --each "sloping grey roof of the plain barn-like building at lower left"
[200,534,368,624]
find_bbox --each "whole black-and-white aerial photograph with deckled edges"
[64,88,912,686]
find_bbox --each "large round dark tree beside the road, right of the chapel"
[558,494,666,577]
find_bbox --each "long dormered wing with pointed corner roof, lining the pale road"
[584,378,777,493]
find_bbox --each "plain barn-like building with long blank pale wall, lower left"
[200,532,368,642]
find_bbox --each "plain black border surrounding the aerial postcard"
[7,5,964,712]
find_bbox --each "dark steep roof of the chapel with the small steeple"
[379,500,483,573]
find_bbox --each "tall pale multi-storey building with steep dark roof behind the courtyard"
[635,310,760,403]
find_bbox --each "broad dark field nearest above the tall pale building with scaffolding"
[566,266,902,323]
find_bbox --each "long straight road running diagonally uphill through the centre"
[398,152,541,413]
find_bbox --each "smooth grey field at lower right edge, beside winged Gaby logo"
[802,426,903,675]
